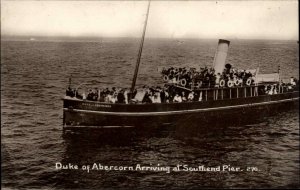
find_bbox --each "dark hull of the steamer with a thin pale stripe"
[63,92,299,128]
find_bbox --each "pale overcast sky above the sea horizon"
[1,0,298,40]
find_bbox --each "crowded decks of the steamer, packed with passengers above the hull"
[66,64,299,104]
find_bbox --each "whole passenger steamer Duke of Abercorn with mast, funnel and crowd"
[63,2,299,129]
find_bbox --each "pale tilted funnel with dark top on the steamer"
[214,39,230,74]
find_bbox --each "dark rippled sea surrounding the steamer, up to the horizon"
[1,39,300,189]
